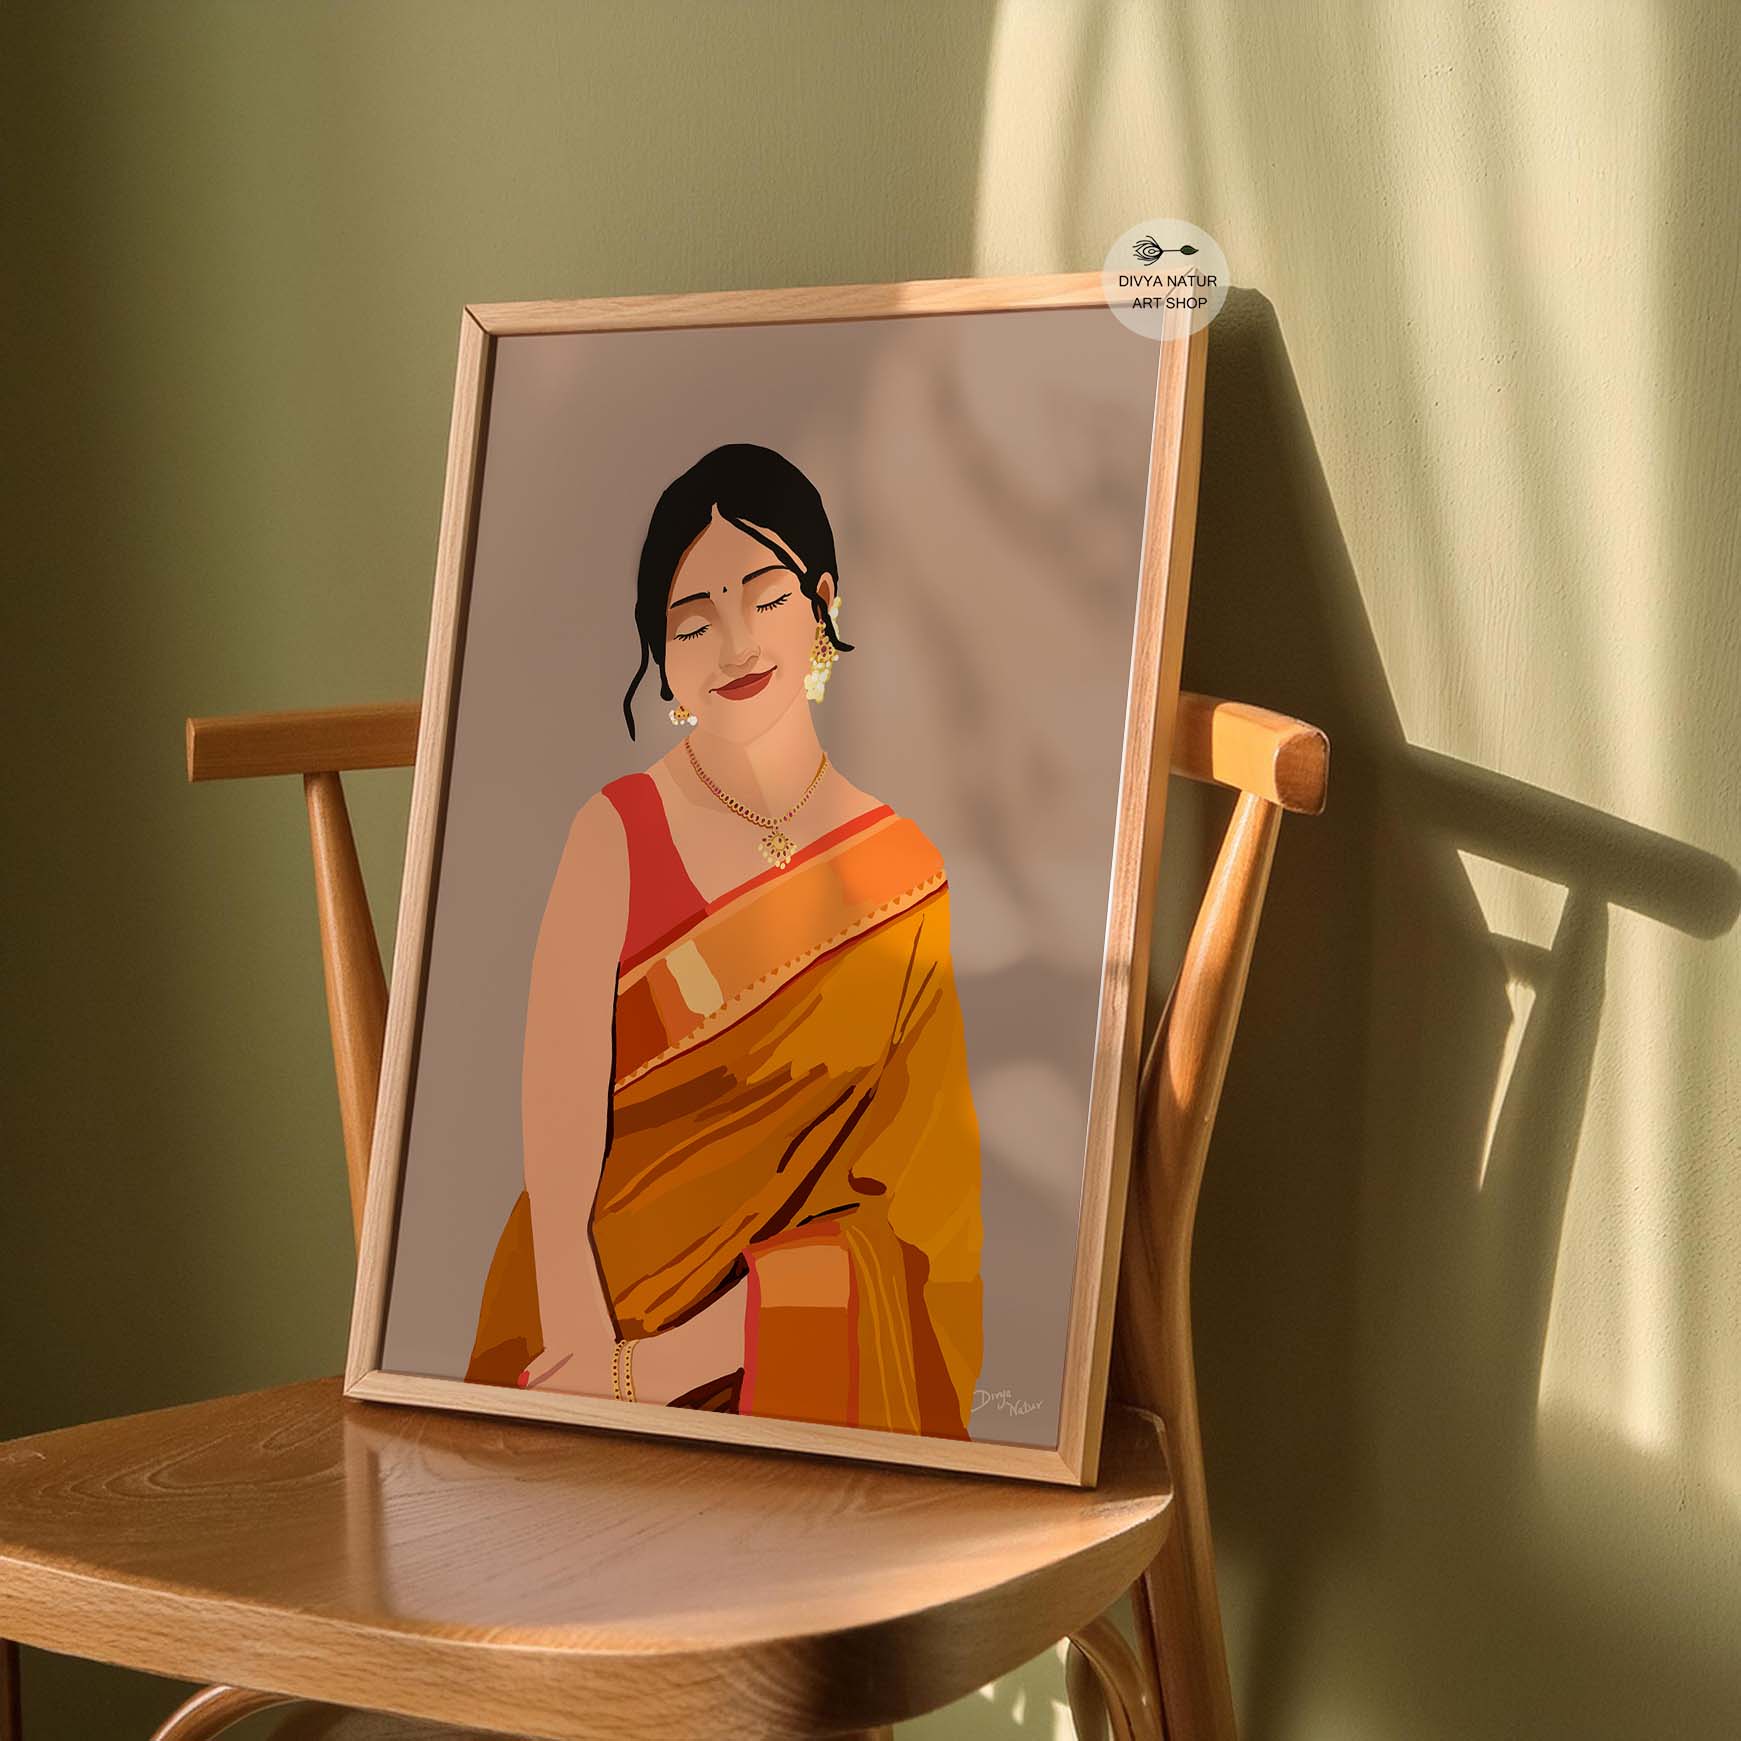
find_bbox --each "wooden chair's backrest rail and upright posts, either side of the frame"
[188,693,1330,1741]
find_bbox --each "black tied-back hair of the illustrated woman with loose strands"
[623,442,851,736]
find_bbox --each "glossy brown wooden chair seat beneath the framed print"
[0,1379,1172,1741]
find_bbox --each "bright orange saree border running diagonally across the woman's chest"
[613,817,949,1090]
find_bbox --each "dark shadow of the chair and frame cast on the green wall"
[1186,291,1741,1741]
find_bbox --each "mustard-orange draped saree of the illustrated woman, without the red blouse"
[467,811,982,1438]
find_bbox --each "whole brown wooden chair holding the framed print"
[0,695,1328,1741]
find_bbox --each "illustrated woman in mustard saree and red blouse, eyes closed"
[467,444,982,1438]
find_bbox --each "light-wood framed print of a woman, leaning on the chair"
[346,273,1207,1485]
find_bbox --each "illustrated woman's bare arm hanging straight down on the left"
[521,794,629,1396]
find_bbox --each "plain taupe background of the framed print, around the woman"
[381,310,1156,1445]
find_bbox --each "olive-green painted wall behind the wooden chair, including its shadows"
[0,0,1741,1741]
